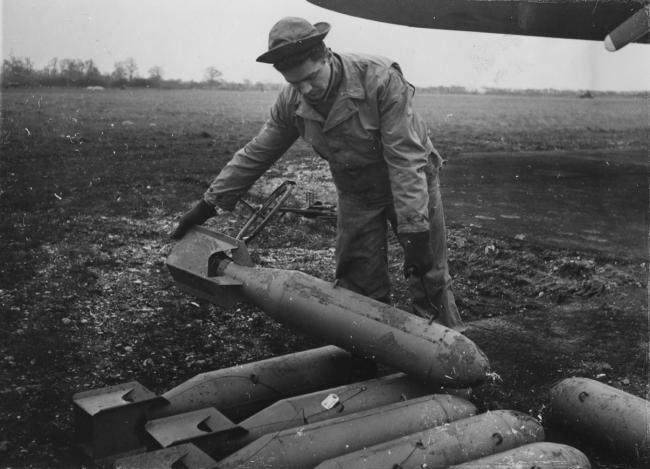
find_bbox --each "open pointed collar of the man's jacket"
[296,53,366,132]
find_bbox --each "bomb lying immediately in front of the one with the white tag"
[219,395,476,469]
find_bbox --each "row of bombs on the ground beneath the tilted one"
[74,346,589,469]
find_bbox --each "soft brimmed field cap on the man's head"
[257,17,330,64]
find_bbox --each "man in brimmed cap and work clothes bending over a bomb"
[172,18,464,330]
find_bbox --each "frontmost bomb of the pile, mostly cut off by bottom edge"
[448,442,591,469]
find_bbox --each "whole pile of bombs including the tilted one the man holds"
[74,228,644,469]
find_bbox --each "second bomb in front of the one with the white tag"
[317,410,544,469]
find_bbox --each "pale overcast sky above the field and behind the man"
[0,0,650,91]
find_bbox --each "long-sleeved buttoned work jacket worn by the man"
[204,54,441,233]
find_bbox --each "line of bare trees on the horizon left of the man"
[0,56,280,90]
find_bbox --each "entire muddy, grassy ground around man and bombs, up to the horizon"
[0,91,650,469]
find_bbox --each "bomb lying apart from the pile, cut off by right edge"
[548,377,650,458]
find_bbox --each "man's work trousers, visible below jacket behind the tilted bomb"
[336,169,465,330]
